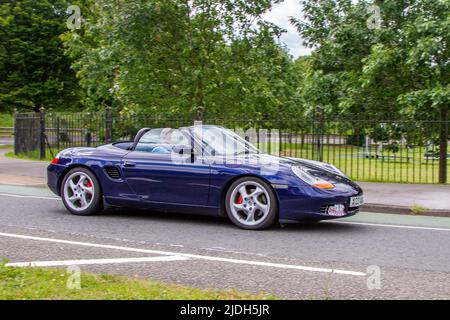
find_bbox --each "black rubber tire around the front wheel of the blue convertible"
[225,177,278,230]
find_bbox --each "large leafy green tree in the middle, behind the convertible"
[65,0,297,120]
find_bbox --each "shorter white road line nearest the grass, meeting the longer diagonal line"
[5,256,189,268]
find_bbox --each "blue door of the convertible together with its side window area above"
[122,129,211,206]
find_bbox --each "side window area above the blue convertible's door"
[136,128,189,154]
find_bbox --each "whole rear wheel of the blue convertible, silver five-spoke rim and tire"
[61,168,102,216]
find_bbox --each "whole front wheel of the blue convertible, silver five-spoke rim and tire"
[225,177,278,230]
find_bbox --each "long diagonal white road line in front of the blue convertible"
[0,233,366,277]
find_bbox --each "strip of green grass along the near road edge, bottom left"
[0,265,275,300]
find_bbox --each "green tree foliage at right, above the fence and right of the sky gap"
[292,0,450,119]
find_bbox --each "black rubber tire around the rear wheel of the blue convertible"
[60,167,103,216]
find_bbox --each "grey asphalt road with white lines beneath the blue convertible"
[0,186,450,299]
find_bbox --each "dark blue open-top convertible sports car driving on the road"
[48,126,363,230]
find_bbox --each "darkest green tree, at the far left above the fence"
[0,0,81,111]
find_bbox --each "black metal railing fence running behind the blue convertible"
[15,109,450,183]
